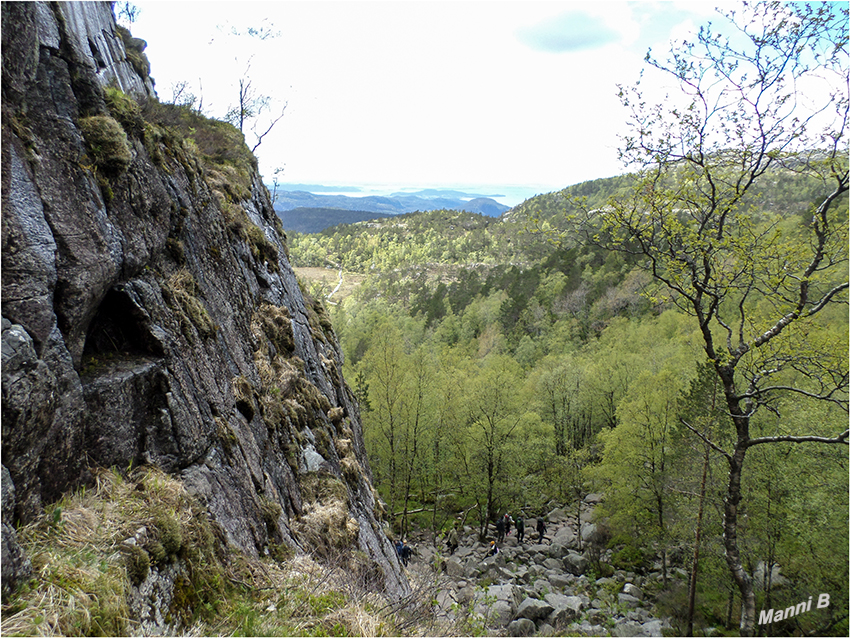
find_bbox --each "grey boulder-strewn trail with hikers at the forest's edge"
[398,495,685,636]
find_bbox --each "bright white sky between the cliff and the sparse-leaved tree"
[129,0,732,203]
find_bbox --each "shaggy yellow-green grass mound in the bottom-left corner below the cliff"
[0,468,199,636]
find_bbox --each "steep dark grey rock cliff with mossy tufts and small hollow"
[2,2,408,595]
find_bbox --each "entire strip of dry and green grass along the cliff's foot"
[0,467,414,636]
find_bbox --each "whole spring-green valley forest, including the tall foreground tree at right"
[289,4,848,635]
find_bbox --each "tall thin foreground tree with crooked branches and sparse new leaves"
[577,2,848,635]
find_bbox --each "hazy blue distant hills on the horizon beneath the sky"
[275,189,510,220]
